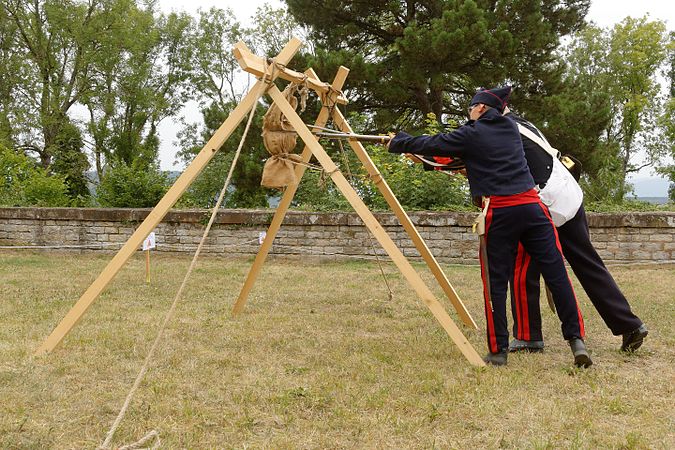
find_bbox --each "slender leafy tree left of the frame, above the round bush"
[82,0,192,176]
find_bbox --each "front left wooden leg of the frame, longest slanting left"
[35,40,301,355]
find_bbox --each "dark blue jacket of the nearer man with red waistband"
[389,109,534,197]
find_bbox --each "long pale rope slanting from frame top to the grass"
[99,60,274,449]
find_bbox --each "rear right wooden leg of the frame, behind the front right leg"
[333,108,478,330]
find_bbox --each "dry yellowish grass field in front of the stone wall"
[0,252,675,449]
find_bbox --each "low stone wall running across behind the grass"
[0,208,675,264]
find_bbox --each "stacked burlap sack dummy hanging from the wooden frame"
[260,83,307,188]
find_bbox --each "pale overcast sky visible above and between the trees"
[157,0,675,194]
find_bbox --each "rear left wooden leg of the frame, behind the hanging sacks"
[232,67,349,314]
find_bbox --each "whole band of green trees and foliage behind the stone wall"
[0,0,675,209]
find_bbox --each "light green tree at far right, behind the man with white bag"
[542,17,668,201]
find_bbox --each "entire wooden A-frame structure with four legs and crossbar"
[35,38,485,366]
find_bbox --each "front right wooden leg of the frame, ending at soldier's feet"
[268,86,485,367]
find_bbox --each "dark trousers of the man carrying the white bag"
[511,205,642,341]
